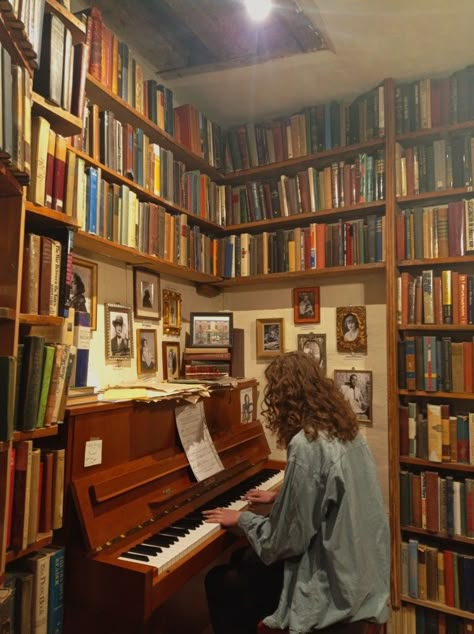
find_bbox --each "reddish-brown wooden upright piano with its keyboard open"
[58,381,284,634]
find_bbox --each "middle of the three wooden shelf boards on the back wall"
[224,200,385,233]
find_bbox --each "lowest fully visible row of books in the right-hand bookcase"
[401,539,474,612]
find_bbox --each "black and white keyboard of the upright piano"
[119,469,284,573]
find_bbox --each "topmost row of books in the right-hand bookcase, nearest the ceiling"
[395,66,474,134]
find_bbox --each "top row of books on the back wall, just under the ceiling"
[225,85,385,172]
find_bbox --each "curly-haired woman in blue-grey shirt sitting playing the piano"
[204,352,390,634]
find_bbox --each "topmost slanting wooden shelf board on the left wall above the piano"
[86,74,222,181]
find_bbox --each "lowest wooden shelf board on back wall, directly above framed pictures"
[215,262,386,286]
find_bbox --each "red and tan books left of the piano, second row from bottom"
[7,440,64,551]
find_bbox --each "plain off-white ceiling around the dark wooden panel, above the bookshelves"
[162,0,474,124]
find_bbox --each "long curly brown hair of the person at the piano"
[262,352,359,447]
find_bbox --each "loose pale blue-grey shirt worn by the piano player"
[239,431,390,634]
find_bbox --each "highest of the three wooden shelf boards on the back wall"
[222,138,385,180]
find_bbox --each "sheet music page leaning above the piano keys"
[175,401,224,482]
